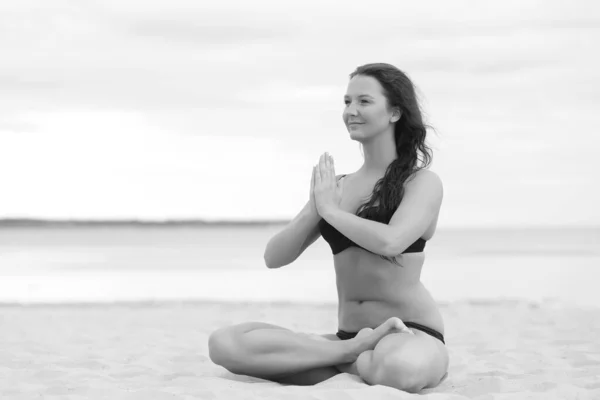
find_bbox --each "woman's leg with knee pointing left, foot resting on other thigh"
[209,318,403,384]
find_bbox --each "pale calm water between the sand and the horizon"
[0,225,600,307]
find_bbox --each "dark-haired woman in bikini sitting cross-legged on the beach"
[209,64,448,392]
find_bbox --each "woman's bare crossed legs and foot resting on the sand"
[209,318,448,392]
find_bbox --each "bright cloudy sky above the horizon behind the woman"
[0,0,600,227]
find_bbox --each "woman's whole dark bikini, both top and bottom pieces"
[319,175,446,344]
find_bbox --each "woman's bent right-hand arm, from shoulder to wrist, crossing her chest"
[321,170,443,257]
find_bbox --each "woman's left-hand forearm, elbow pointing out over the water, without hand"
[264,201,321,268]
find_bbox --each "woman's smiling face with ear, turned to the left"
[343,75,399,142]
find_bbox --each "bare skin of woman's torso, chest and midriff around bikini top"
[326,174,444,334]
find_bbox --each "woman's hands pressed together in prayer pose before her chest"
[313,153,342,216]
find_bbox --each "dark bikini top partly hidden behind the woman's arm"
[319,175,427,255]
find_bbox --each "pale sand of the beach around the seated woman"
[0,301,600,400]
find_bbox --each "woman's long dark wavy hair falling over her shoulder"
[350,63,432,264]
